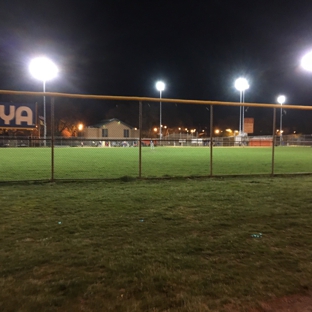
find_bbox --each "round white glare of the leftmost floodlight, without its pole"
[29,57,58,81]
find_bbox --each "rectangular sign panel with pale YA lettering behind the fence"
[0,103,36,129]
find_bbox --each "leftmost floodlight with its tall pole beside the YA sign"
[29,57,58,146]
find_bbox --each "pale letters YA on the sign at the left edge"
[0,104,33,126]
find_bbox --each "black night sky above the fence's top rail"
[0,0,312,132]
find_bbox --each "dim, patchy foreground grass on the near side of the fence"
[0,176,312,311]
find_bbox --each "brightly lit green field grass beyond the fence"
[0,147,312,181]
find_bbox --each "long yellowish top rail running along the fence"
[0,90,312,110]
